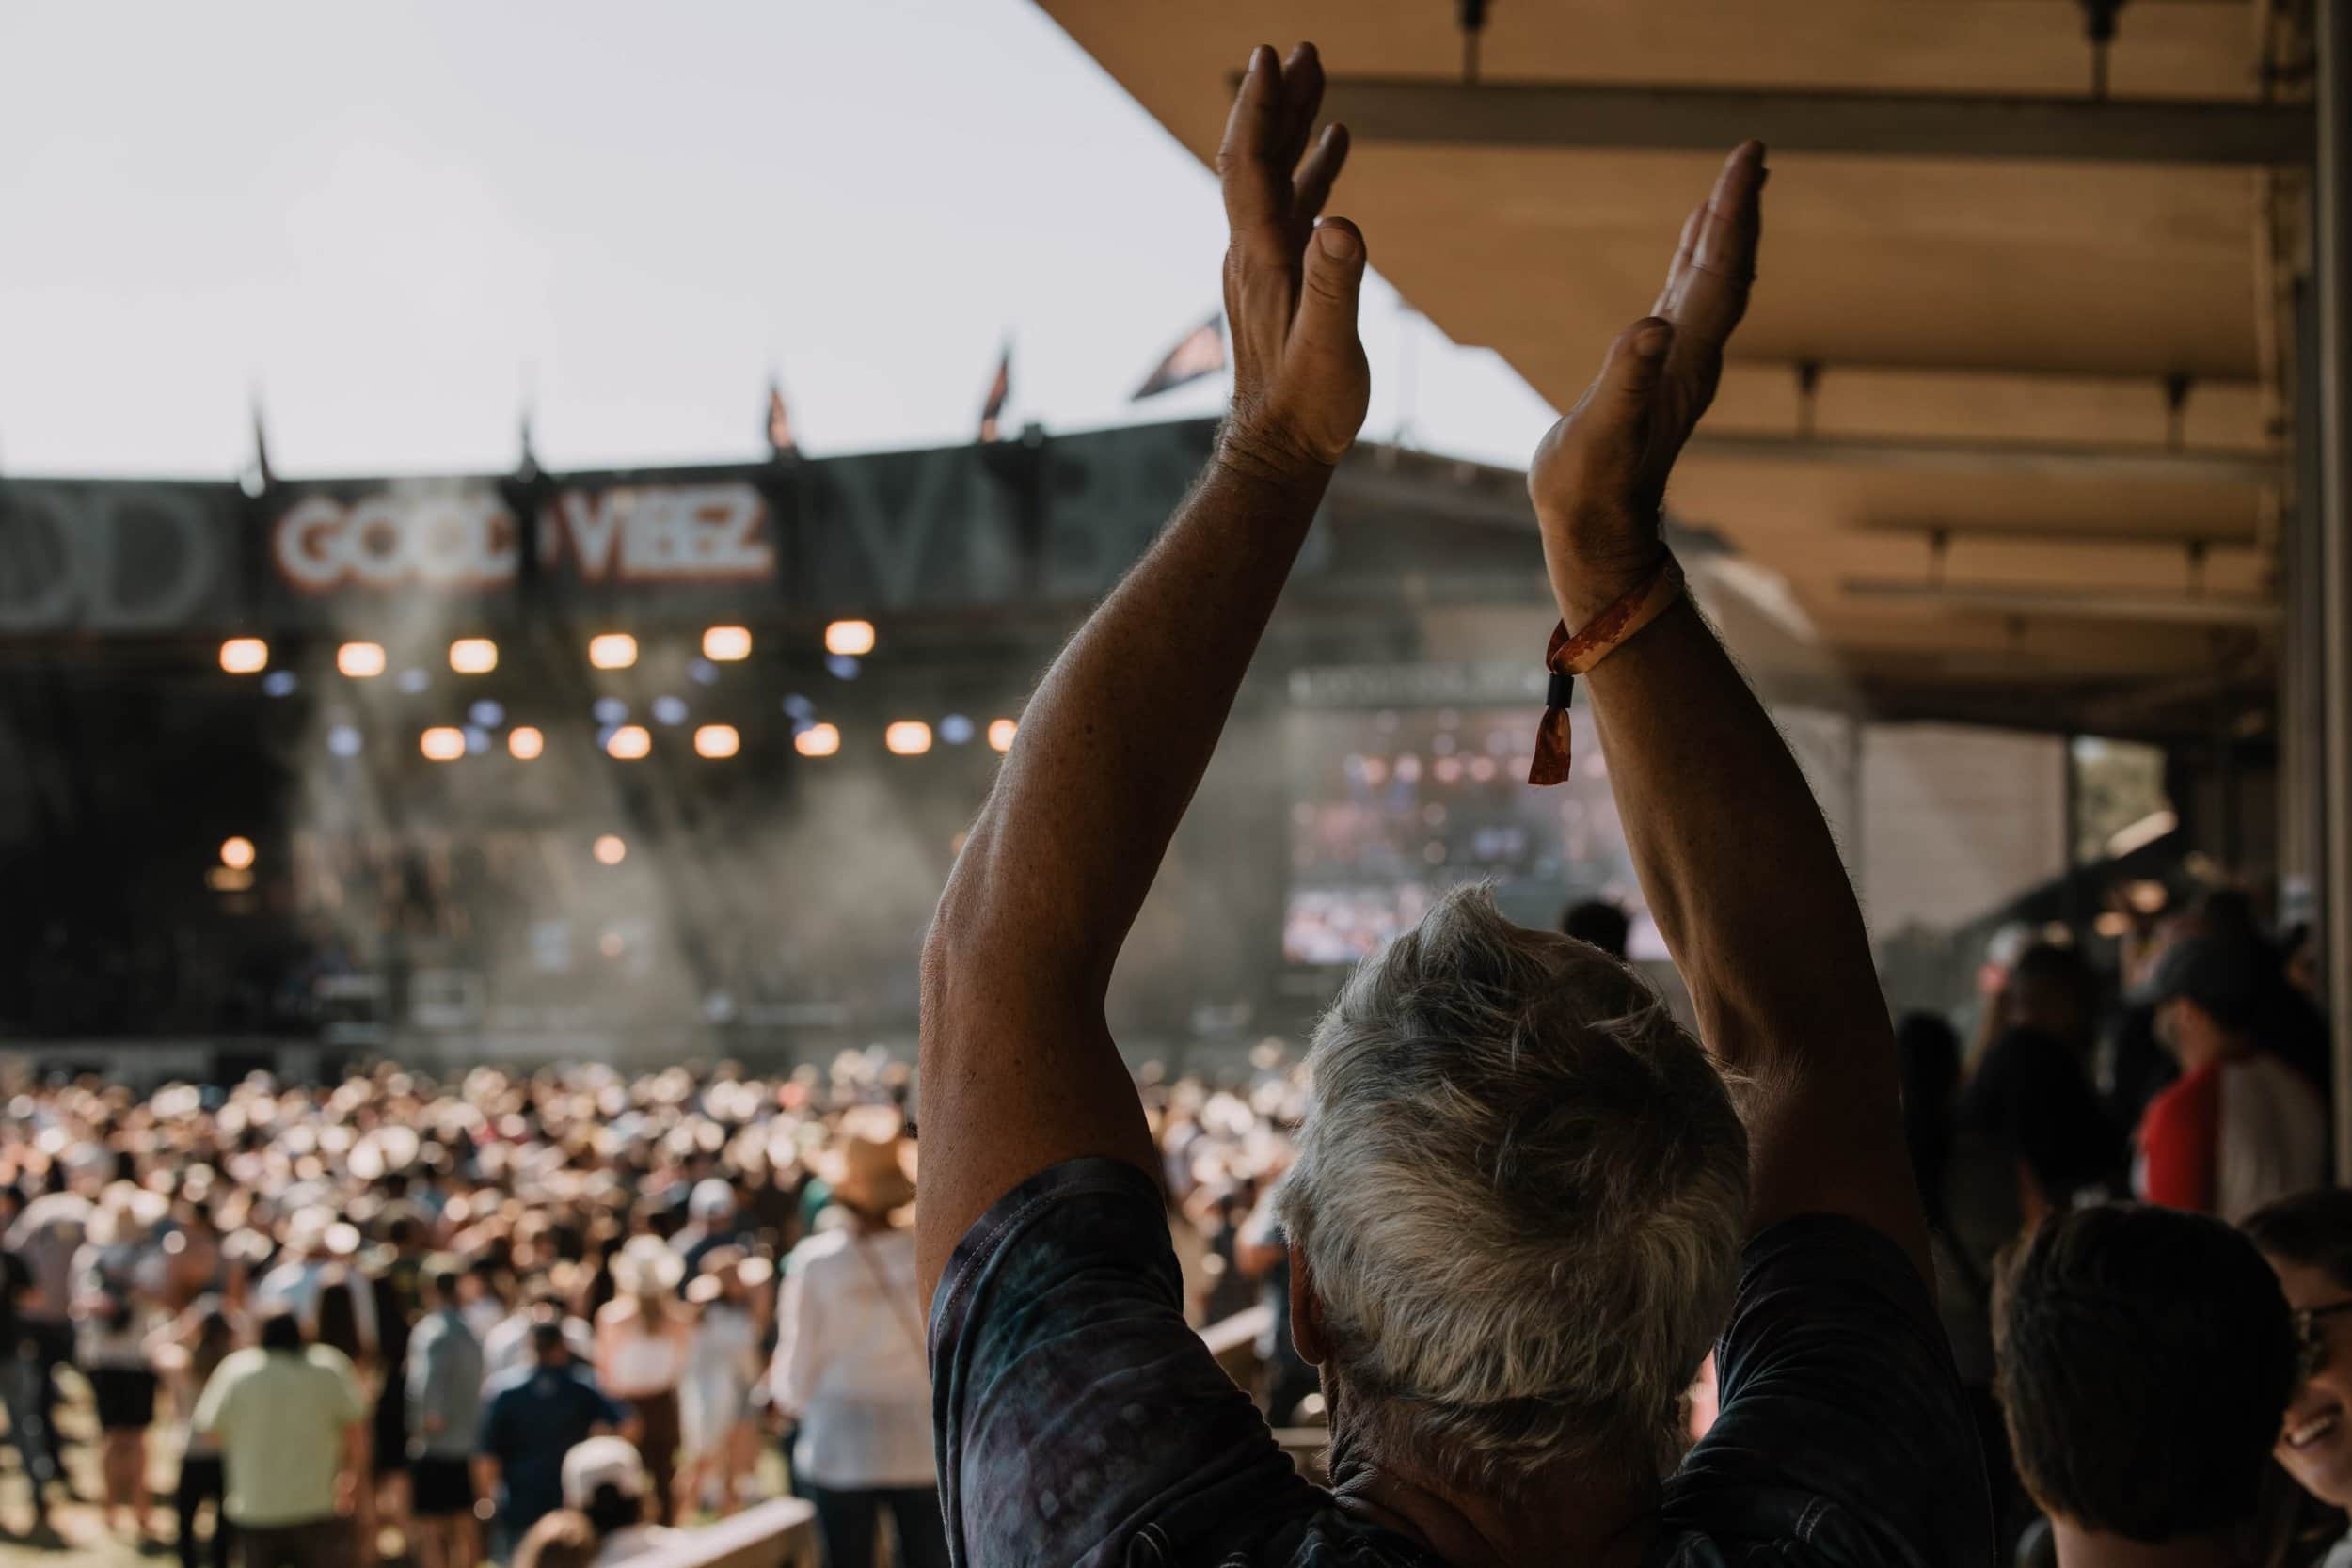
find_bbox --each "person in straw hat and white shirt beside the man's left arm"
[770,1105,948,1568]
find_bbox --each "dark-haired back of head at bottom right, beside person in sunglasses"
[1994,1204,2296,1543]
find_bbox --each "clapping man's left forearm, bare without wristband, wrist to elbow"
[934,447,1331,1006]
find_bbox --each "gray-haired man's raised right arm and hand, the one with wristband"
[1529,143,1929,1272]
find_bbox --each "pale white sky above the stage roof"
[0,0,1550,477]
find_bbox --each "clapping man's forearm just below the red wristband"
[1585,602,1894,1082]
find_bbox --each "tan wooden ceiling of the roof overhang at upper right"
[1040,0,2305,734]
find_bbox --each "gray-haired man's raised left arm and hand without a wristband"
[915,44,1369,1303]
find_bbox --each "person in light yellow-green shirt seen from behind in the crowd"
[191,1312,370,1568]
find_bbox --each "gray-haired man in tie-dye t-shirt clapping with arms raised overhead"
[917,44,1993,1568]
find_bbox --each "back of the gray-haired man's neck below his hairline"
[1331,1449,1659,1568]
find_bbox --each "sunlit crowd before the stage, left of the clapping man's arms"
[0,1055,964,1568]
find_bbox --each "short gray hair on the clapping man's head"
[1278,886,1748,1493]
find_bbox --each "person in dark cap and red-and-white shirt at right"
[2134,936,2328,1225]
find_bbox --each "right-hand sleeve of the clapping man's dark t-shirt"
[1668,1215,1993,1568]
